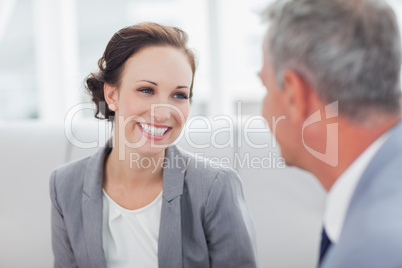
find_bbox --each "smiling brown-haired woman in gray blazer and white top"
[50,23,256,268]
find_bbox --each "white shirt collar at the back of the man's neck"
[324,132,389,244]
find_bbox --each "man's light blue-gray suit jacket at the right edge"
[322,122,402,268]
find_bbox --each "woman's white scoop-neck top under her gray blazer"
[102,190,162,268]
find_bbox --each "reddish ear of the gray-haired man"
[282,70,312,122]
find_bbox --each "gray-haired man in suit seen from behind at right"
[260,0,402,268]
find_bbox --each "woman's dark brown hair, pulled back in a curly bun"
[85,23,196,120]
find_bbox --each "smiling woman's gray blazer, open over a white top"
[50,146,257,268]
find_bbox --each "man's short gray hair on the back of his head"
[263,0,401,121]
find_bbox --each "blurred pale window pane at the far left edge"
[0,0,39,120]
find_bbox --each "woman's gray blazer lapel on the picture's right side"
[158,146,188,268]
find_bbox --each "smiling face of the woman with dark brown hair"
[105,47,193,155]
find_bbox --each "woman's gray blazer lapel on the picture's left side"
[82,148,107,268]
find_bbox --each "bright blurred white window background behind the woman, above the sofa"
[0,0,270,122]
